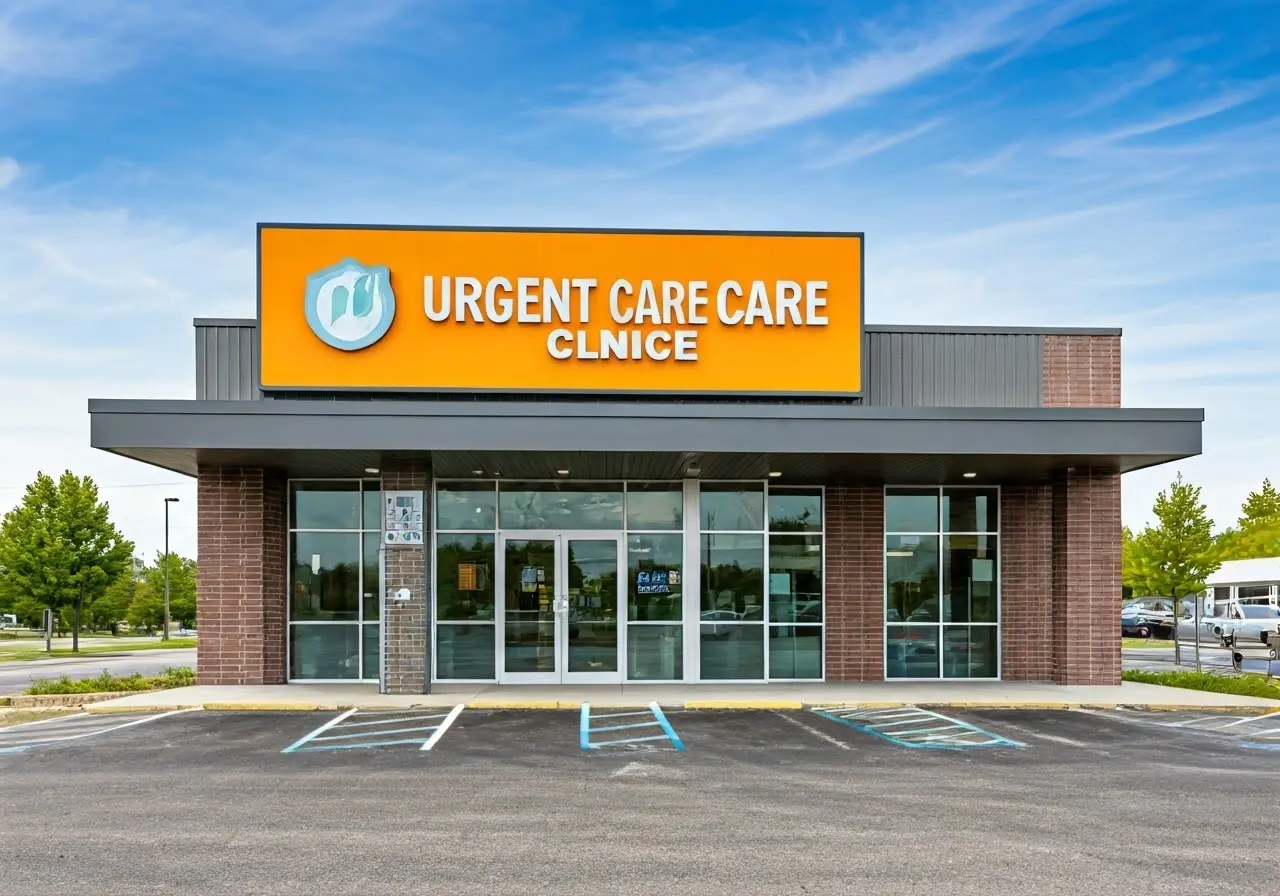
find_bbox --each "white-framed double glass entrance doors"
[499,532,623,684]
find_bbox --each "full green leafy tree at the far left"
[0,470,133,652]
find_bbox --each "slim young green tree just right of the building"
[1132,474,1222,663]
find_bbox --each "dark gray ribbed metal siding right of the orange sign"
[865,326,1044,407]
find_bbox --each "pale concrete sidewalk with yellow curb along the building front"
[84,681,1280,713]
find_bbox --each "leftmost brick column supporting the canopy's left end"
[196,466,288,685]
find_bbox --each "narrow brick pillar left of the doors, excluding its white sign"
[383,460,431,694]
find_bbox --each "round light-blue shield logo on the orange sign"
[303,259,396,352]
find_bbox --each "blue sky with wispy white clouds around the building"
[0,0,1280,557]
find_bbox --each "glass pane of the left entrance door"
[503,539,556,672]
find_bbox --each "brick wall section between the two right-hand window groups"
[824,485,884,681]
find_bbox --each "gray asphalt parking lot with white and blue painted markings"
[0,707,1280,896]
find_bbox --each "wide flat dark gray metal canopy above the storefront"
[90,401,1203,483]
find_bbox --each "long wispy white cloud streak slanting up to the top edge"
[579,0,1089,150]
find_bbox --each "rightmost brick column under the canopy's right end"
[1051,467,1120,685]
